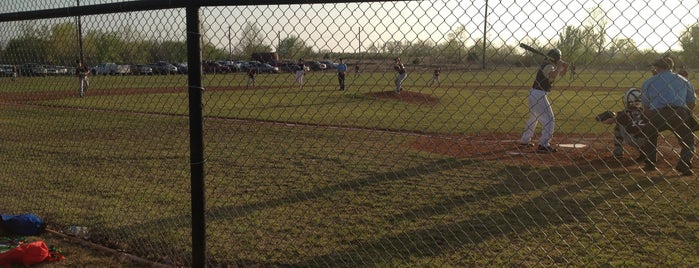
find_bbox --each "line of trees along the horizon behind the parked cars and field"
[0,16,699,68]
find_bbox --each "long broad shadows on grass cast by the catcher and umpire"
[290,161,664,267]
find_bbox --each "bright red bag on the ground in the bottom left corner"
[0,241,65,267]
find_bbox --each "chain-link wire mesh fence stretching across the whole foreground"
[0,0,699,267]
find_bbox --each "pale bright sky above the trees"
[0,0,699,52]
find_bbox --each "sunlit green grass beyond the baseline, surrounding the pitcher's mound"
[30,69,660,133]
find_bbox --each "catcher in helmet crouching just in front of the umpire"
[596,88,648,157]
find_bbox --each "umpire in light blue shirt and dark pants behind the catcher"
[641,57,697,176]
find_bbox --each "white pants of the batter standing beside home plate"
[520,88,555,146]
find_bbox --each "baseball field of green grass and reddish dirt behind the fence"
[0,68,699,267]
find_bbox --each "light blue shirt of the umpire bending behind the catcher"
[641,70,697,110]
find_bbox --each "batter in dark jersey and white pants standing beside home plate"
[520,48,568,153]
